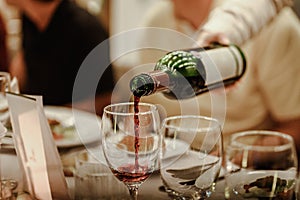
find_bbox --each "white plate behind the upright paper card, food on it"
[44,106,101,148]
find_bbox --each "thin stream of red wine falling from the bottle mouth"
[134,96,140,172]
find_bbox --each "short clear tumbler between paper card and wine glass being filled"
[74,150,129,200]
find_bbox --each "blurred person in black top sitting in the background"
[6,0,113,114]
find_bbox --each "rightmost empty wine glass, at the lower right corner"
[225,130,298,200]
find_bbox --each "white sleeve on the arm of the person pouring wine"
[201,0,293,45]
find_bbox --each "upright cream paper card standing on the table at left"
[7,93,70,199]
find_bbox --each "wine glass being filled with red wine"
[101,102,161,199]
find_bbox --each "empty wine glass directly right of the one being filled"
[160,115,223,200]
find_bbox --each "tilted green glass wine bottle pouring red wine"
[130,44,246,99]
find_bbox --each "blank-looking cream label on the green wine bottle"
[191,46,243,85]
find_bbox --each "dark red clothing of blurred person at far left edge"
[0,15,8,71]
